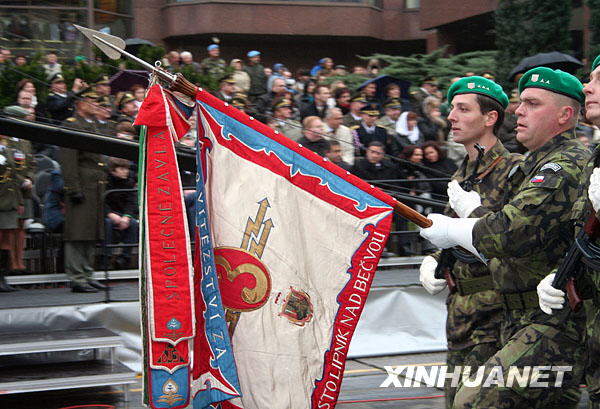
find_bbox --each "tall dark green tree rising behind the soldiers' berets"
[495,0,571,88]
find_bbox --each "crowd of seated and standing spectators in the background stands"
[0,44,595,291]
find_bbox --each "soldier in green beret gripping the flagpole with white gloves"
[421,67,589,408]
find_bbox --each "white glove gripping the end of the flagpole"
[420,213,481,258]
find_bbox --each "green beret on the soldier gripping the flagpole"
[519,67,585,104]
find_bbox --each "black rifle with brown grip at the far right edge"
[552,210,600,311]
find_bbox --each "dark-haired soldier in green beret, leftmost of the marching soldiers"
[420,77,521,409]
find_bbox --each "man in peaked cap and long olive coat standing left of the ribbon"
[59,88,106,293]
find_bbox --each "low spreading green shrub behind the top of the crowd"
[328,48,496,89]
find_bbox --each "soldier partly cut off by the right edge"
[537,56,600,409]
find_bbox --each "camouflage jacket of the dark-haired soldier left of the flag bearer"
[436,140,523,350]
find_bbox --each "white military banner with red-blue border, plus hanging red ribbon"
[138,82,404,409]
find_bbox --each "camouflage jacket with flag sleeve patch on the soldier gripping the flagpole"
[473,131,590,293]
